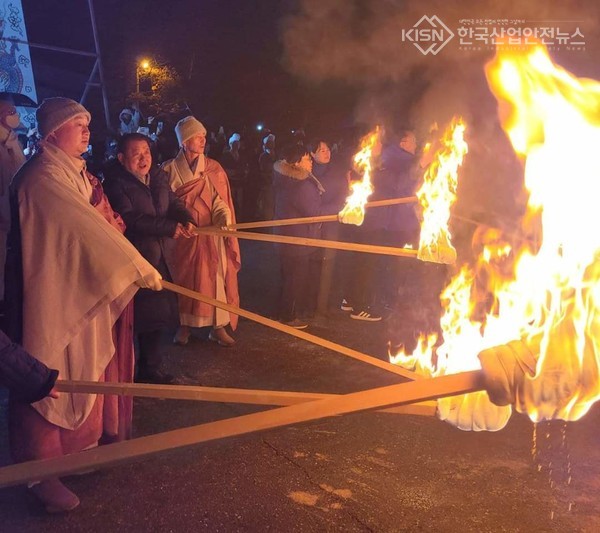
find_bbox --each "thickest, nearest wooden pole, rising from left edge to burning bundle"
[0,371,483,487]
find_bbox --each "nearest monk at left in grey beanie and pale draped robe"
[10,98,161,512]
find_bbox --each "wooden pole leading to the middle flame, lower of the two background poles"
[194,226,417,258]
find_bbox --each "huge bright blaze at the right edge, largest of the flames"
[393,45,600,429]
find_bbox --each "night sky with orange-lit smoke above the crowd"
[16,0,600,155]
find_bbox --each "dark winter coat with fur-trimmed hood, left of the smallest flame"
[273,161,324,256]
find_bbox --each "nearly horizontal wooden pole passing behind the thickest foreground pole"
[55,380,436,416]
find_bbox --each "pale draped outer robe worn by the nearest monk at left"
[13,143,153,430]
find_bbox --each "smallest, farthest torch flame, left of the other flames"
[338,126,381,226]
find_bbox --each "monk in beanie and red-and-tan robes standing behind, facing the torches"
[163,116,241,346]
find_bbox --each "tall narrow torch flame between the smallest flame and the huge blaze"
[417,117,468,263]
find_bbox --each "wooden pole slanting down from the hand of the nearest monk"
[162,280,419,379]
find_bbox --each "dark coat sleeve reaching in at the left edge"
[0,331,58,403]
